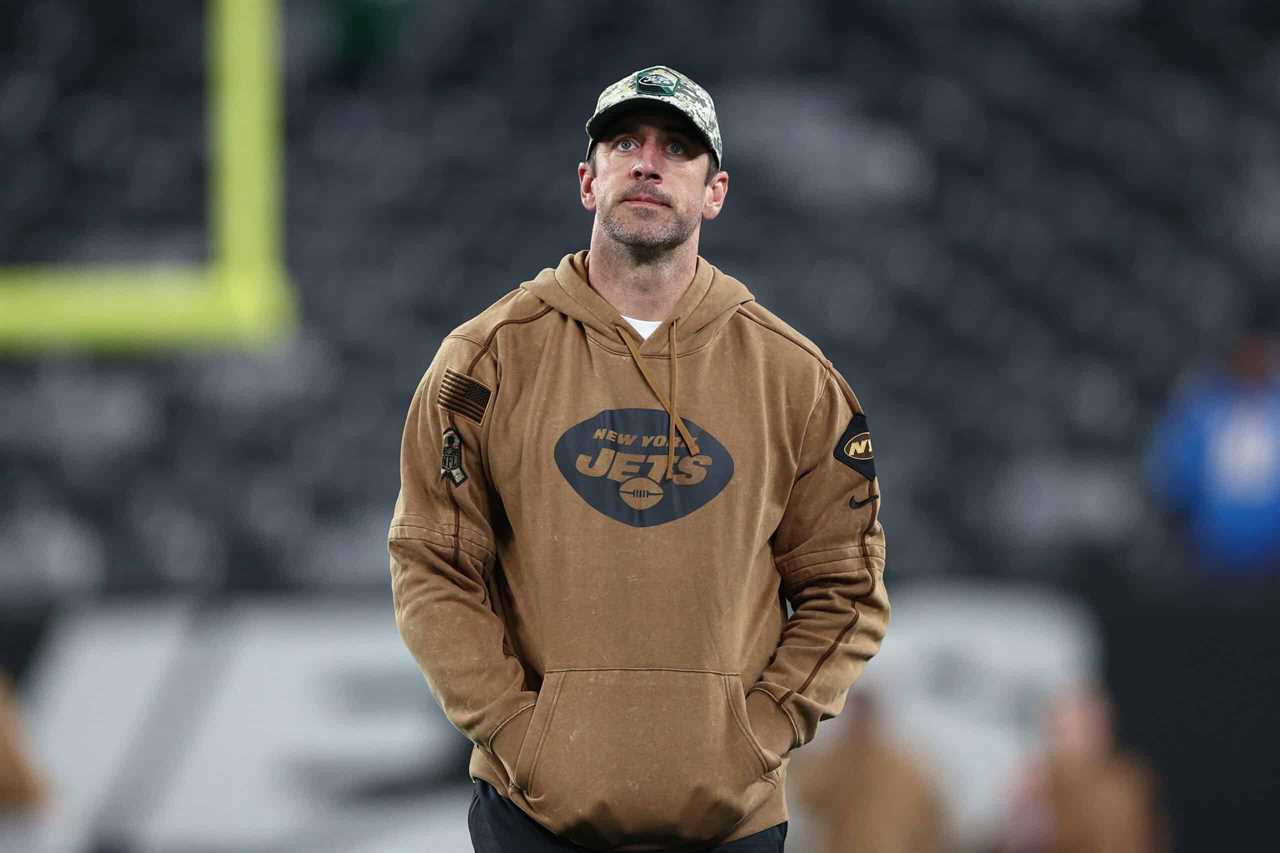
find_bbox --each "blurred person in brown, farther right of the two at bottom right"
[995,685,1169,853]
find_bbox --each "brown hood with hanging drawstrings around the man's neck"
[522,250,755,479]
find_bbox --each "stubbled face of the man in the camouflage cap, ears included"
[577,110,728,252]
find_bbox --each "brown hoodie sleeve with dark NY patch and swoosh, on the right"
[746,364,890,756]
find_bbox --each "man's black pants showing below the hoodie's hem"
[467,779,787,853]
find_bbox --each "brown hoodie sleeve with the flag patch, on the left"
[388,336,538,776]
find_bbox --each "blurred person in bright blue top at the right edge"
[1147,305,1280,576]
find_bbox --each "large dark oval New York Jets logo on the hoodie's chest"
[556,409,733,528]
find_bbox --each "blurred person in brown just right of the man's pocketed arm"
[791,689,947,853]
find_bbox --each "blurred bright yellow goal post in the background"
[0,0,297,352]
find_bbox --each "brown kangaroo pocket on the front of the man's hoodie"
[515,669,782,849]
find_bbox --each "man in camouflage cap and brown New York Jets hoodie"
[389,67,888,853]
